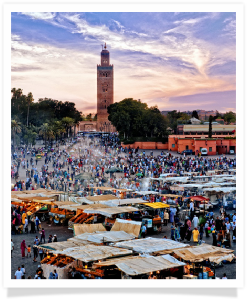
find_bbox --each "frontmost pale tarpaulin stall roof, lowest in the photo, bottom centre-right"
[116,254,186,276]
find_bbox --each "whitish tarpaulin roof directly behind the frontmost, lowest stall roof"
[114,238,188,253]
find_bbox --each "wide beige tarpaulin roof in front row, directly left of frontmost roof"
[50,245,132,263]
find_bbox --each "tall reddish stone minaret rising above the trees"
[97,43,113,132]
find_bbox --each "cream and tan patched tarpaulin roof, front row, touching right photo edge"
[173,244,235,264]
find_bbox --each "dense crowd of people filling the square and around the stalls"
[11,137,236,279]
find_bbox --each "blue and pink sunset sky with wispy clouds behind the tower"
[11,12,236,114]
